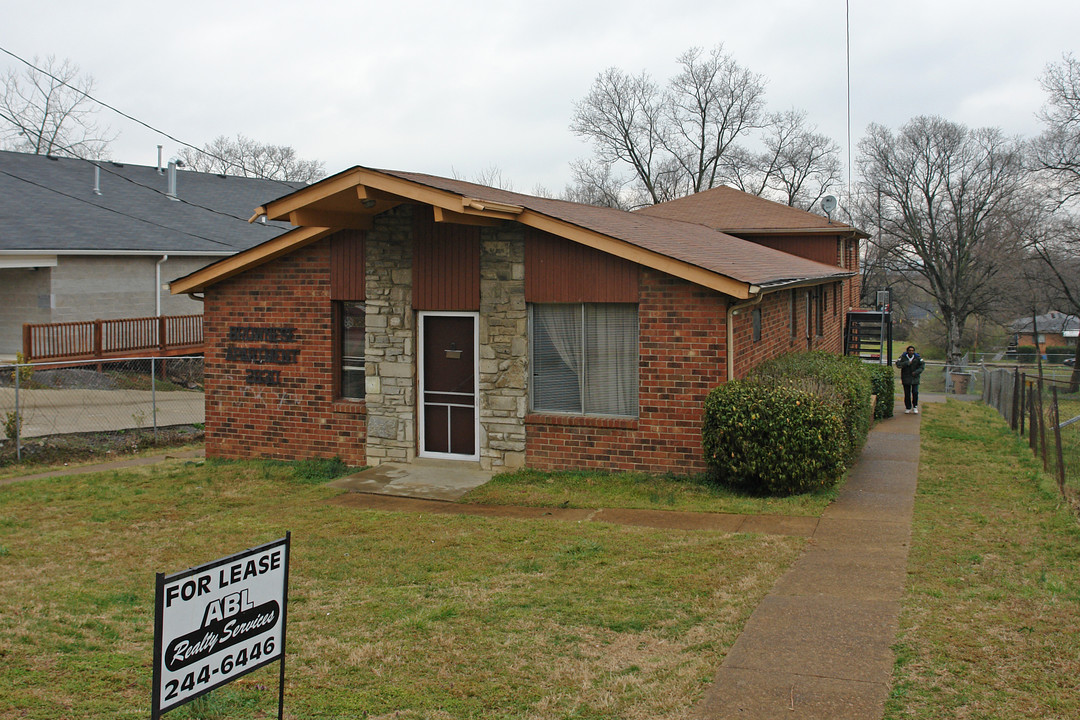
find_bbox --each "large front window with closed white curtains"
[529,303,638,417]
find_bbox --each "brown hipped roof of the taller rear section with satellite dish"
[635,186,865,236]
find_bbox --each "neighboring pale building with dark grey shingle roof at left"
[0,151,302,358]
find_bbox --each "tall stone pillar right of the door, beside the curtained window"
[480,227,529,470]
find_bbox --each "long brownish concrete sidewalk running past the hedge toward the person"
[693,408,920,720]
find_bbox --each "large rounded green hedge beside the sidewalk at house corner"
[702,351,876,494]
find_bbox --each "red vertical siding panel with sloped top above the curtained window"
[525,230,639,302]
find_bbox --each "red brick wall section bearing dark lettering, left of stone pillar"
[203,241,365,465]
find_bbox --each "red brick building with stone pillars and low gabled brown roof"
[172,167,865,474]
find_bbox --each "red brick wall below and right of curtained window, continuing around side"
[526,269,843,475]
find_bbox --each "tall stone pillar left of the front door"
[364,205,417,465]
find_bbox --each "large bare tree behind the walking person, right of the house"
[859,117,1025,363]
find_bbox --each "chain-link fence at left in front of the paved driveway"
[0,356,203,460]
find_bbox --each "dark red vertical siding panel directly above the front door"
[413,207,480,311]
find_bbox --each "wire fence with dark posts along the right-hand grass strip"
[982,368,1080,501]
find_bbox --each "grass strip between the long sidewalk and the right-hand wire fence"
[886,403,1080,720]
